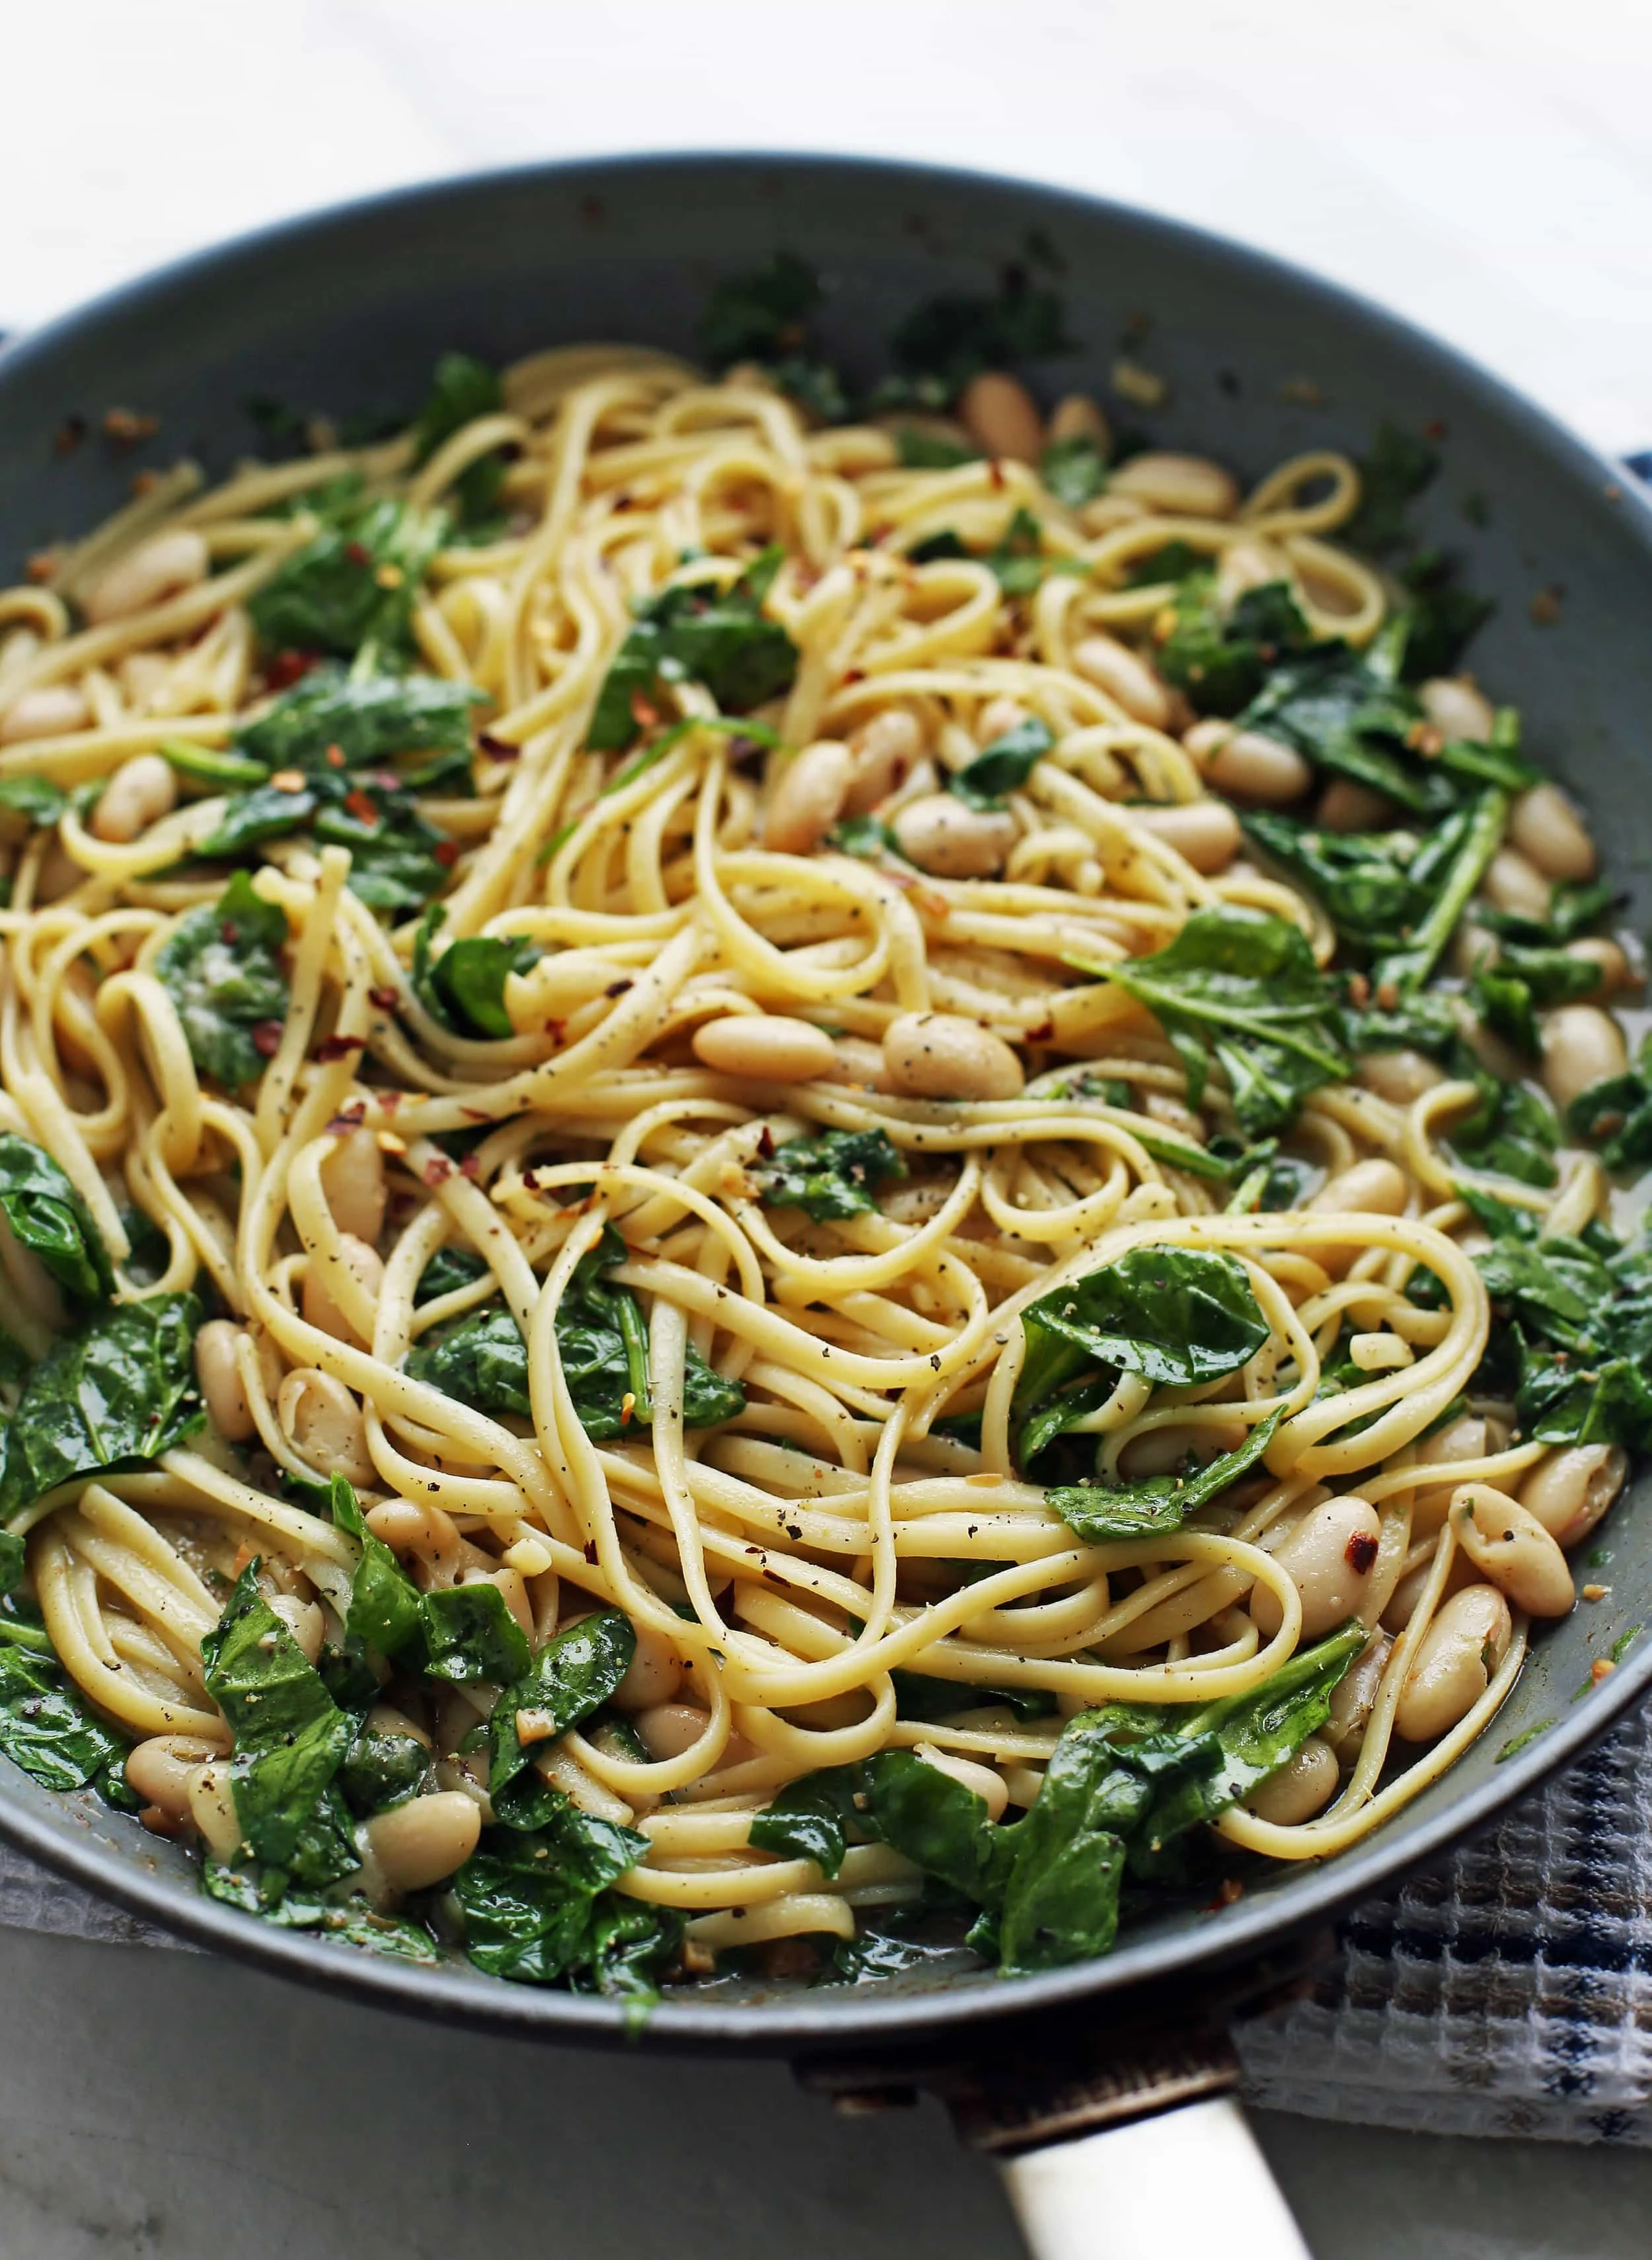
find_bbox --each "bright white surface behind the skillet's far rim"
[0,0,1652,450]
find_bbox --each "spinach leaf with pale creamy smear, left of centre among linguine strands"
[156,870,287,1092]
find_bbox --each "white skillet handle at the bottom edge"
[999,2095,1313,2260]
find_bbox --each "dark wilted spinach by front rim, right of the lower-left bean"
[454,1799,683,2002]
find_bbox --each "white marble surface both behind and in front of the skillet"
[0,0,1652,2260]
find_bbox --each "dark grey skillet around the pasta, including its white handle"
[0,156,1652,2255]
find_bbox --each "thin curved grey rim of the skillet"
[0,149,1652,2056]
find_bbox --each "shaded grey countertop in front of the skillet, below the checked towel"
[0,1930,1652,2260]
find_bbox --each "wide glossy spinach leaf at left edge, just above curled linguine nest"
[0,1295,204,1519]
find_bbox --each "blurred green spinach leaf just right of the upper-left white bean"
[246,497,447,660]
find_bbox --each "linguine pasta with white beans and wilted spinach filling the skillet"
[0,267,1652,1993]
